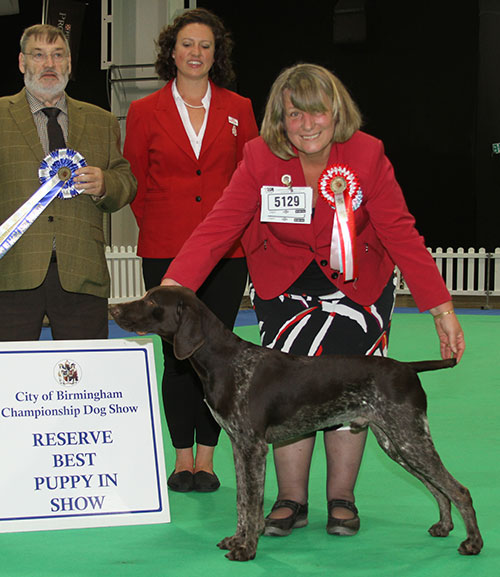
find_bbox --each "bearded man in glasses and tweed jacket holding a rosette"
[0,24,136,341]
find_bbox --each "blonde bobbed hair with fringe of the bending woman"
[261,64,362,160]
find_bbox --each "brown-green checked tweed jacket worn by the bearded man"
[0,89,136,297]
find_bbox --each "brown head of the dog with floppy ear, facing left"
[109,286,205,360]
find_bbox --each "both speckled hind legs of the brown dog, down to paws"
[372,414,483,555]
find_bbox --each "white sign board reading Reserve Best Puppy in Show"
[0,340,170,533]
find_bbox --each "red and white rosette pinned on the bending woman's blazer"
[318,164,363,281]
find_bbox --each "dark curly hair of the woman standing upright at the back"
[155,8,235,87]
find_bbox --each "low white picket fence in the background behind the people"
[106,246,500,303]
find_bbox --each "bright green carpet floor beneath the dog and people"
[0,314,500,577]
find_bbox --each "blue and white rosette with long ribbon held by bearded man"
[0,148,87,258]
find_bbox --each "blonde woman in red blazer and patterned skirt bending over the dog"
[162,64,465,535]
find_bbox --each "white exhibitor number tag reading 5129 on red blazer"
[260,186,313,224]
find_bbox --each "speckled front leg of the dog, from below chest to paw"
[218,435,268,561]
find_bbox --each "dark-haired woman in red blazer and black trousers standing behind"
[124,8,258,492]
